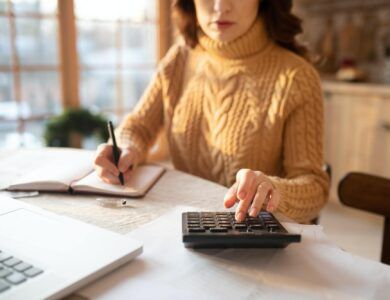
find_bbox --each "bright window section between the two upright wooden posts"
[75,0,157,117]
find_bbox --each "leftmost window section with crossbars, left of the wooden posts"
[0,0,61,145]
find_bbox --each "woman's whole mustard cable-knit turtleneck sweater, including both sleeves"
[117,20,329,222]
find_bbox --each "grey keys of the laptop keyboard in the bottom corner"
[0,250,43,293]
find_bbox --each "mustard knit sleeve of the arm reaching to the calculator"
[270,66,329,223]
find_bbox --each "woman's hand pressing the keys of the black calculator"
[224,169,280,222]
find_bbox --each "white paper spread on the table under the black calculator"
[79,207,390,300]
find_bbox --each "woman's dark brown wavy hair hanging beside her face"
[173,0,309,60]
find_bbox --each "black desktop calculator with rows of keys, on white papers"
[182,211,301,248]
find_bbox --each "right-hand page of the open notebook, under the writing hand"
[72,165,165,196]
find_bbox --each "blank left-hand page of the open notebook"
[4,148,94,189]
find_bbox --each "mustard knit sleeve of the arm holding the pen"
[116,45,183,163]
